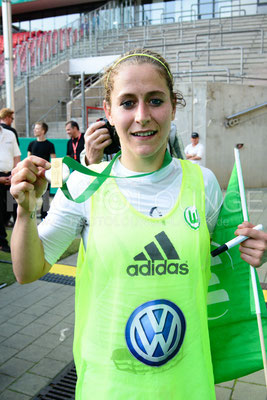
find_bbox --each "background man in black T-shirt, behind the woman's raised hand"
[28,122,56,219]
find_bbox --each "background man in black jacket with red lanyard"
[65,121,84,162]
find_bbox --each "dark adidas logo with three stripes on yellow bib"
[126,231,189,276]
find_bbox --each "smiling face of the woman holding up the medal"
[104,63,175,172]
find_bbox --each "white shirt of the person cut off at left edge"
[0,127,21,172]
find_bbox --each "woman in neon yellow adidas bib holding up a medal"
[12,49,267,400]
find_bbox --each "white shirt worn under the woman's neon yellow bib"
[38,159,223,265]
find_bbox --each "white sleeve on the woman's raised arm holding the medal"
[38,172,89,265]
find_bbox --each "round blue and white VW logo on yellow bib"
[125,300,186,367]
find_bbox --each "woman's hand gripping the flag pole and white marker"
[235,222,267,267]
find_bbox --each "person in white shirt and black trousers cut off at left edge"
[0,127,21,252]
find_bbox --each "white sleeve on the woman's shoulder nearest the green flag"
[203,167,223,235]
